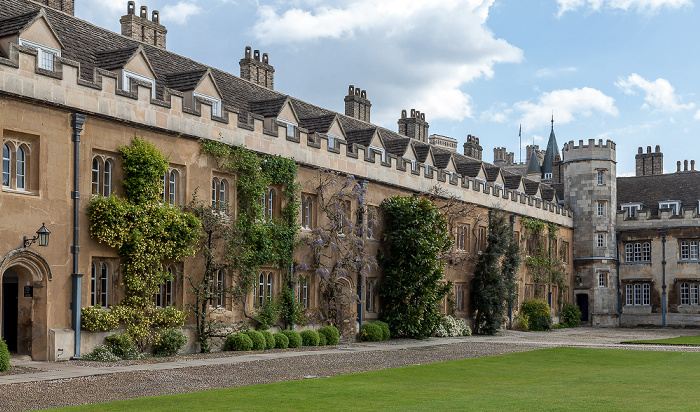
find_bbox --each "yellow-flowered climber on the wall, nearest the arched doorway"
[87,138,200,350]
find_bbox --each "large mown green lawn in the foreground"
[57,348,700,411]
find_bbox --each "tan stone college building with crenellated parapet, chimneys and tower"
[0,0,700,360]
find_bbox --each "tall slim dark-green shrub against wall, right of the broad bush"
[471,209,520,335]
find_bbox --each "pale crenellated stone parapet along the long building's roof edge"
[0,45,576,227]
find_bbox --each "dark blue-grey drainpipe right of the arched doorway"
[70,113,86,359]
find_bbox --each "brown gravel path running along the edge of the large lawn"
[0,328,700,411]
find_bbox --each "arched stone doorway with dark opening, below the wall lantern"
[0,248,51,360]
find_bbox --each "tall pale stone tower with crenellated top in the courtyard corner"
[562,139,619,326]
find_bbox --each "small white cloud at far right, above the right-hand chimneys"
[615,73,695,112]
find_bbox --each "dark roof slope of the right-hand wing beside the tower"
[617,171,700,216]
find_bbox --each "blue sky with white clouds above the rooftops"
[75,0,700,176]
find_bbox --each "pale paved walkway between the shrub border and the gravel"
[0,327,700,385]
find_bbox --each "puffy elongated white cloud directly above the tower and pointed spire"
[513,87,619,130]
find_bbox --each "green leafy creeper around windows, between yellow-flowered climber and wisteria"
[201,140,300,326]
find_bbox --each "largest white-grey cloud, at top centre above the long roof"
[253,0,522,124]
